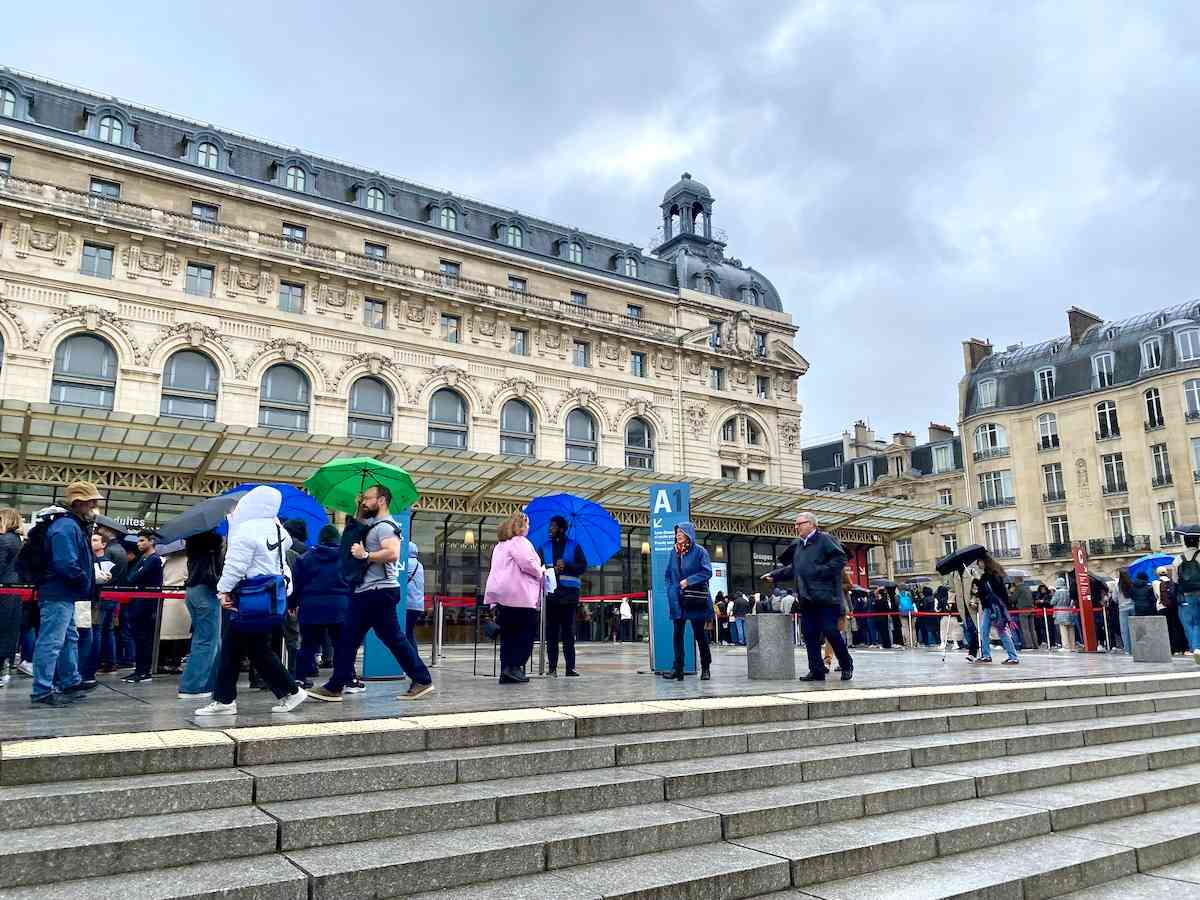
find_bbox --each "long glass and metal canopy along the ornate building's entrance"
[0,401,970,545]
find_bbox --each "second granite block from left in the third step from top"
[262,769,664,850]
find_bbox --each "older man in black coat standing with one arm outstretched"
[762,512,854,682]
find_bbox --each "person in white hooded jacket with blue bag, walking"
[196,485,308,715]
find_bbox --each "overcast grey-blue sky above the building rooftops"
[0,0,1200,443]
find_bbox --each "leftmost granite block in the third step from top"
[0,806,278,888]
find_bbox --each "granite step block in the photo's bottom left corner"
[0,854,308,900]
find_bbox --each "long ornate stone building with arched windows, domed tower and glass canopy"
[0,70,947,609]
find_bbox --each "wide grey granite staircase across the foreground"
[7,673,1200,900]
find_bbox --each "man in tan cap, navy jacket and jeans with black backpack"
[29,481,101,707]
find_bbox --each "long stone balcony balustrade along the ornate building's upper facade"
[0,176,676,340]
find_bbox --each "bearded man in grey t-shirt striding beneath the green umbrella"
[310,485,433,702]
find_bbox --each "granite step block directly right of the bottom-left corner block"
[287,803,721,900]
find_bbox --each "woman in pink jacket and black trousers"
[484,512,544,684]
